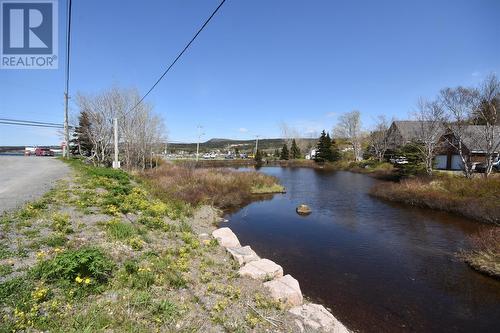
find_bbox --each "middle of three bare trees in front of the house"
[440,87,478,178]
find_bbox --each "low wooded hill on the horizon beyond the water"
[168,138,317,152]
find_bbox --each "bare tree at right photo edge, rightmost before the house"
[474,74,500,177]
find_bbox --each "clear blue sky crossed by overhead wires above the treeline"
[0,0,500,145]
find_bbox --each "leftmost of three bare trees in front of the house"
[414,98,445,175]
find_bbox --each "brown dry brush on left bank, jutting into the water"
[143,164,283,209]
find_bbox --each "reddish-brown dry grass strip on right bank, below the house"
[372,176,500,224]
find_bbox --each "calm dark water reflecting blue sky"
[224,167,500,332]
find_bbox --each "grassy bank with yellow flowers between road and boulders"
[0,161,293,332]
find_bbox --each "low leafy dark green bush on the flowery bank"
[33,247,114,284]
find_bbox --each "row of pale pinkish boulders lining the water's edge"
[208,227,349,333]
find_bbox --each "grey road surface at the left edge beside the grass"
[0,156,69,214]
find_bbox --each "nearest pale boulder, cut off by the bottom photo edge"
[289,303,349,333]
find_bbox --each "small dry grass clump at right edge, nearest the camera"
[461,227,500,279]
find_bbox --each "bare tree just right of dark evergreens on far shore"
[333,110,363,161]
